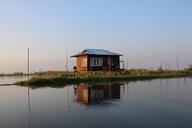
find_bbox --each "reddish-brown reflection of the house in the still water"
[75,83,122,104]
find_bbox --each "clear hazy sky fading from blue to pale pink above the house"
[0,0,192,72]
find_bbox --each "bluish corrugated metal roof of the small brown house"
[72,49,122,57]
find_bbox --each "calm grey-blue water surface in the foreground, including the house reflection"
[0,78,192,128]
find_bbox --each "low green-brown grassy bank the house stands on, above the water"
[16,69,192,87]
